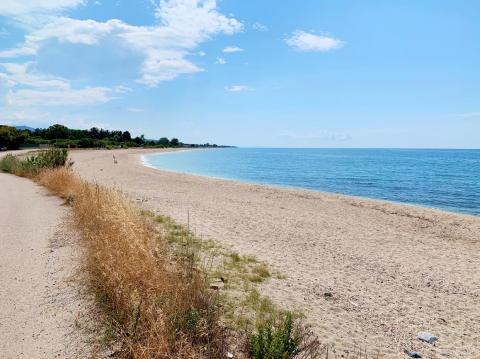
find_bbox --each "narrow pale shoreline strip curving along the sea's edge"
[138,149,480,218]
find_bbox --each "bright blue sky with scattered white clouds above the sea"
[0,0,480,148]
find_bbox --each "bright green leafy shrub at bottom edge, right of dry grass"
[249,313,302,359]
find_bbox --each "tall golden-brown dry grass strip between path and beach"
[37,168,226,358]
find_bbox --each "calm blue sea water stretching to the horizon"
[145,148,480,215]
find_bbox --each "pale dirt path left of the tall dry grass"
[0,173,90,359]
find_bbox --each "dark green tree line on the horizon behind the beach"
[0,124,181,150]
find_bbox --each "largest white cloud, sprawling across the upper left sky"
[0,0,243,86]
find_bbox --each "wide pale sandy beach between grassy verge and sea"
[72,150,480,359]
